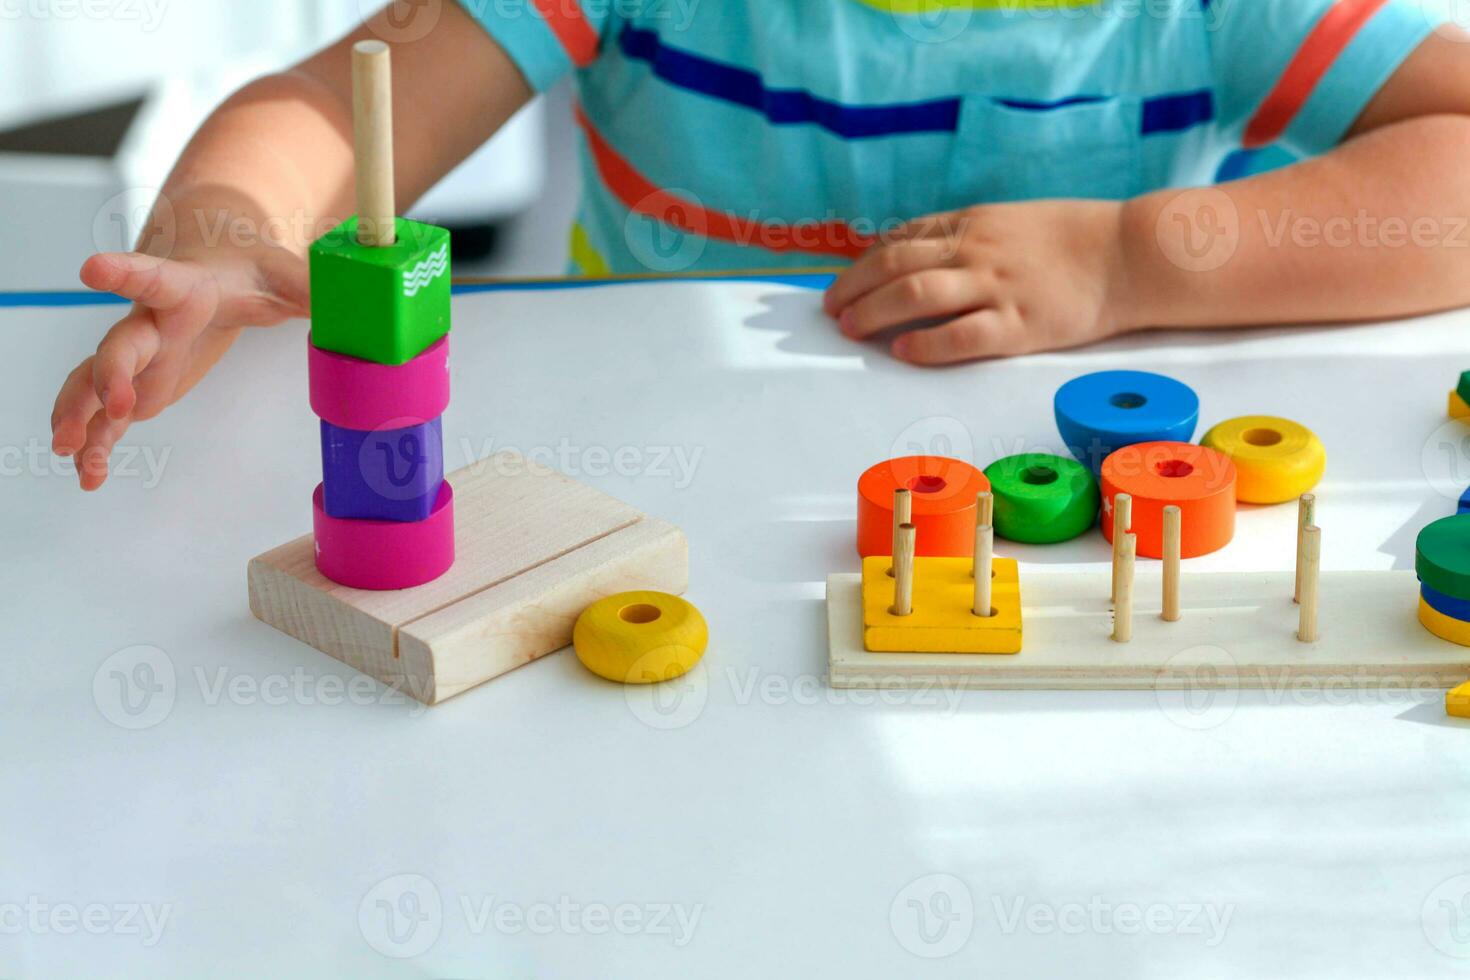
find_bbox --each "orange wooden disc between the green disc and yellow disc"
[1103,442,1235,558]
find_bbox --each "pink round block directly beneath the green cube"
[307,336,450,432]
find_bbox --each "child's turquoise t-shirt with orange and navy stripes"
[460,0,1438,275]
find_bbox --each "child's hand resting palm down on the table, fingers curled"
[825,200,1123,364]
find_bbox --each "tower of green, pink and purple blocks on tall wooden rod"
[307,41,454,589]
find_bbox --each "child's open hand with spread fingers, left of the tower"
[51,248,307,491]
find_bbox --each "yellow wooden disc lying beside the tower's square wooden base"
[572,592,710,685]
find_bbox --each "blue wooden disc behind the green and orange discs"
[1054,370,1200,473]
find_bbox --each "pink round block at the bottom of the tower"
[312,480,454,591]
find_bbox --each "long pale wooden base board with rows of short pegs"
[828,570,1470,691]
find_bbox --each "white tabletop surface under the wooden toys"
[0,284,1470,980]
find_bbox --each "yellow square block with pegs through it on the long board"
[863,555,1020,654]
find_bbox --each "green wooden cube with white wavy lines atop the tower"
[312,217,450,364]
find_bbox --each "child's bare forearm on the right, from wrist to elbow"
[1114,115,1470,329]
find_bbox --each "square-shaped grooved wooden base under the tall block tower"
[248,453,689,704]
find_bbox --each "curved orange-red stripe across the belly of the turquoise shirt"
[576,106,876,259]
